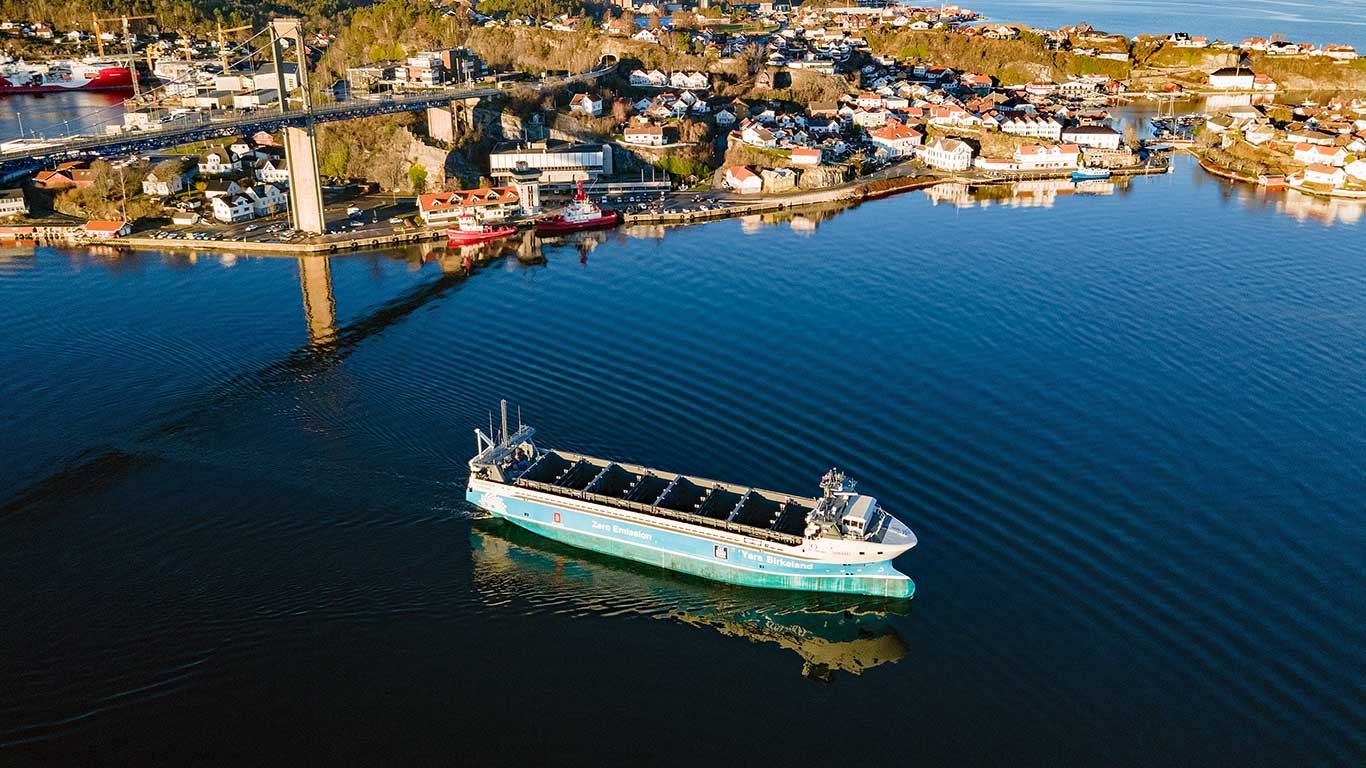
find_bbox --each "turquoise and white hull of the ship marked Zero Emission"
[466,481,915,599]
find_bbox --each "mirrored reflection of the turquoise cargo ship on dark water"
[470,519,910,682]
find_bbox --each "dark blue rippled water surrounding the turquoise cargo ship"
[0,157,1366,767]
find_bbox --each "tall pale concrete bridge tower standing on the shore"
[270,19,328,235]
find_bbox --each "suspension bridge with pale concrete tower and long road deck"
[0,19,616,234]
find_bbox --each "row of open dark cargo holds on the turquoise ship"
[511,451,817,545]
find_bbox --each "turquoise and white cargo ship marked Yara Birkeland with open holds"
[466,402,917,599]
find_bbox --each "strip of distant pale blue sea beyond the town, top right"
[959,0,1366,48]
